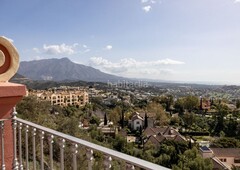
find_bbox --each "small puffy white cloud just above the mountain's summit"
[43,43,76,55]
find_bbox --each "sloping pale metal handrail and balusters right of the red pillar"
[12,117,167,170]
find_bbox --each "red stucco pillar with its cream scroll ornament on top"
[0,37,26,169]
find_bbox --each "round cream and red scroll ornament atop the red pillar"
[0,36,19,82]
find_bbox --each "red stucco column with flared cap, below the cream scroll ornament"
[0,82,26,169]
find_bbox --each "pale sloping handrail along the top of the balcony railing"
[13,117,168,170]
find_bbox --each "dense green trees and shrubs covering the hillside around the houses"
[17,94,240,170]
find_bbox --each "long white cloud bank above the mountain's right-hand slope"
[90,57,184,78]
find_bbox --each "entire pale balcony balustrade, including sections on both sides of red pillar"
[0,110,170,170]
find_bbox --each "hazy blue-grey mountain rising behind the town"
[18,58,124,82]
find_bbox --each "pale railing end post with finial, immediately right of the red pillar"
[12,107,18,170]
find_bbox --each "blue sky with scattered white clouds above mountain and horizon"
[0,0,240,84]
